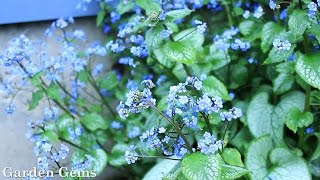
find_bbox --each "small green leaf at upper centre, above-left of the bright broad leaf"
[145,25,164,51]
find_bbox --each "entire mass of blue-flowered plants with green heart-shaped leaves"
[0,0,320,180]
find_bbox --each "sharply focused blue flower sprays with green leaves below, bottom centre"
[117,77,248,179]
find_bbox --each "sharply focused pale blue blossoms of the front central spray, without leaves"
[118,77,242,164]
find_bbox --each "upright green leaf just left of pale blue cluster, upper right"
[261,22,284,53]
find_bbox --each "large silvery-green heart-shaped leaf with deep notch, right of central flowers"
[247,91,304,143]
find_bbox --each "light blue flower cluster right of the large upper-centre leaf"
[213,27,251,51]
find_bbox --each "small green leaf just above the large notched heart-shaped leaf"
[273,73,295,94]
